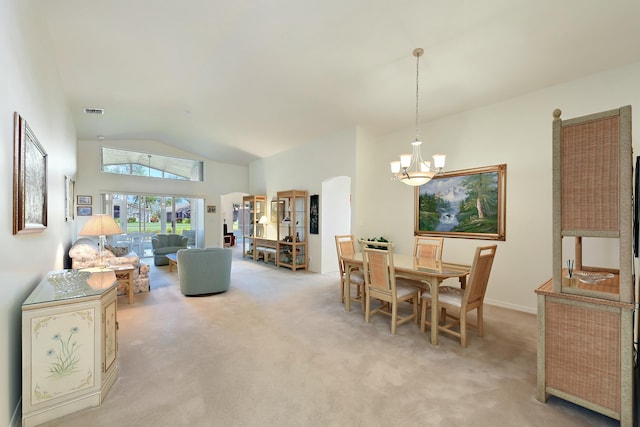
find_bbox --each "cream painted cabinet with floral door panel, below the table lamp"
[22,270,118,426]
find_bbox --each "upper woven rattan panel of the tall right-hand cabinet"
[561,116,620,231]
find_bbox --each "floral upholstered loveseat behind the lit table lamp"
[69,237,150,295]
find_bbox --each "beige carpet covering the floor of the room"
[42,247,618,427]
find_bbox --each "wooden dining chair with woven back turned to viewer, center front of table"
[360,240,420,334]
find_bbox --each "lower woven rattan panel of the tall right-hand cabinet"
[545,300,621,413]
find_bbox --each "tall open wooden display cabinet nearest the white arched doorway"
[277,190,309,271]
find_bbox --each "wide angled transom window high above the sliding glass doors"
[101,147,204,181]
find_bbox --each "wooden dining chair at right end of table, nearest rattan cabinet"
[420,245,498,347]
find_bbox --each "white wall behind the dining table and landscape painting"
[358,63,640,312]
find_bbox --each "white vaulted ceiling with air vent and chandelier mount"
[30,0,640,164]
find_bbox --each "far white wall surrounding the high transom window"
[77,140,248,247]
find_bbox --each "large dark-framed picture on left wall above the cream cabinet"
[13,112,47,234]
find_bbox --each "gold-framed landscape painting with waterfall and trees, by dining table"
[415,164,507,240]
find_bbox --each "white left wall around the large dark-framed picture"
[0,0,76,426]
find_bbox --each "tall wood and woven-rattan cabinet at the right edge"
[536,106,635,426]
